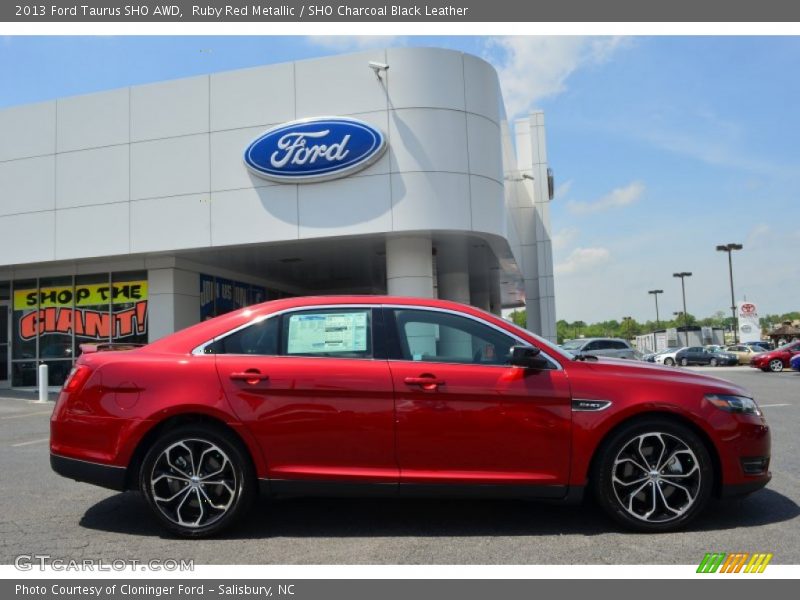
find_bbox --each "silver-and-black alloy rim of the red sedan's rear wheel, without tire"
[150,439,238,528]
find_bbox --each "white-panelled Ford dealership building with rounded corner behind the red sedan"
[0,48,555,387]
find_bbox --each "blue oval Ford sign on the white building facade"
[244,117,386,183]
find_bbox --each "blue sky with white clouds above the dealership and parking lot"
[0,36,800,322]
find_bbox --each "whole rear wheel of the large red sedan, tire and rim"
[139,423,258,538]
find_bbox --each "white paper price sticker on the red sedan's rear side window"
[286,312,367,354]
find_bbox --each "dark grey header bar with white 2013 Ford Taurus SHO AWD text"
[0,0,800,23]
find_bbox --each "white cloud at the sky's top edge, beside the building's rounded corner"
[486,36,627,118]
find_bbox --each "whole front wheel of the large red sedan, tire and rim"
[591,417,714,532]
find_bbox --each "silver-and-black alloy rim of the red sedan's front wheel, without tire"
[611,431,701,523]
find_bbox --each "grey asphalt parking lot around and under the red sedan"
[0,367,800,564]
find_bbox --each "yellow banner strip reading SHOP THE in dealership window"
[14,281,147,310]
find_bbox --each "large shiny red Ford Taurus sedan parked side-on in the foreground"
[50,296,770,537]
